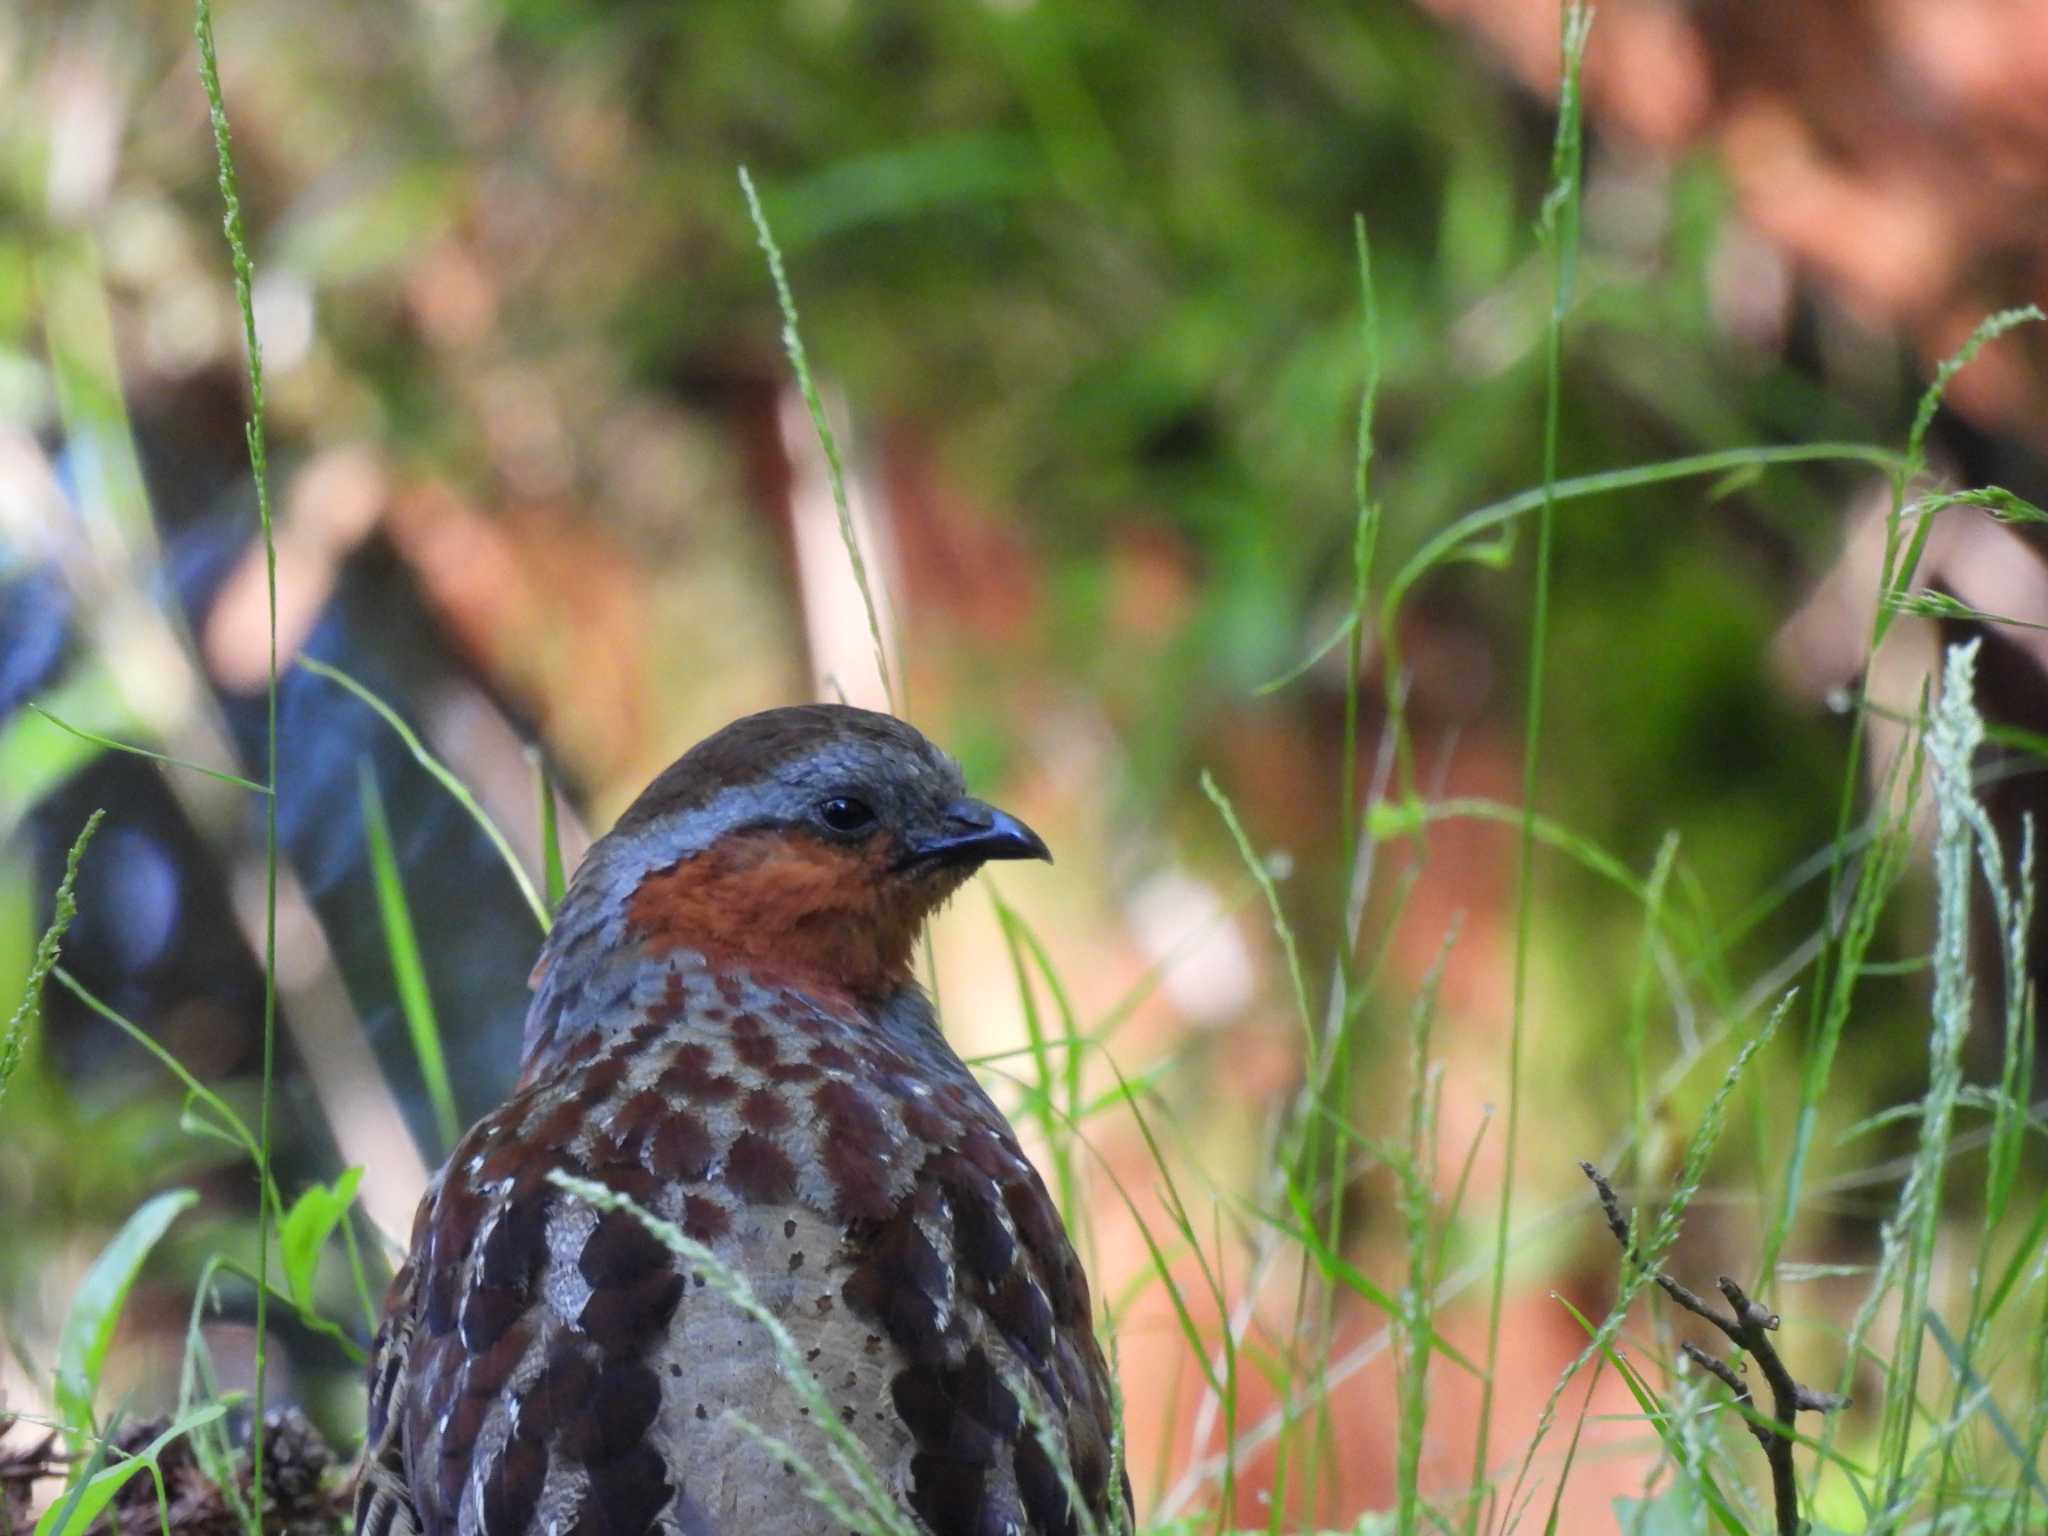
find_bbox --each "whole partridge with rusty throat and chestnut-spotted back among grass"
[354,705,1130,1536]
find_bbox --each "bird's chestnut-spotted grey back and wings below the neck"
[356,952,1128,1536]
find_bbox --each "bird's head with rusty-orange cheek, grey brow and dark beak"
[543,705,1051,999]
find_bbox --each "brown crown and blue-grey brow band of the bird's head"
[578,705,967,889]
